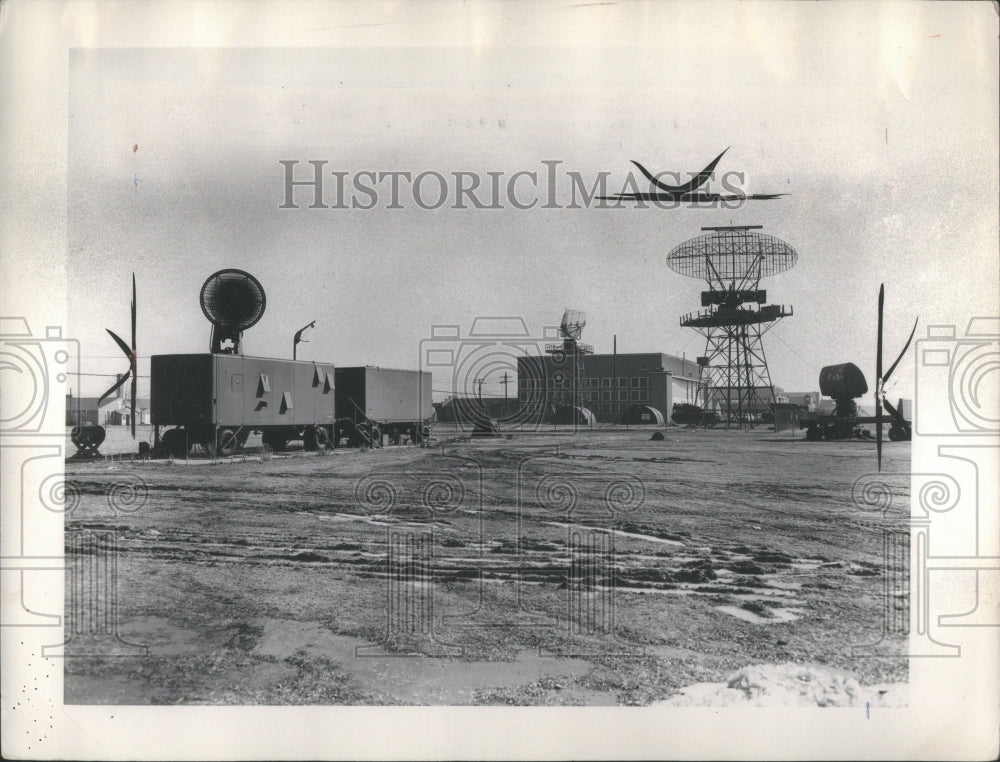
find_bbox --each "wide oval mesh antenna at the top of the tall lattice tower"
[667,227,799,281]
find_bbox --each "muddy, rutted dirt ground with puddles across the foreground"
[65,426,909,705]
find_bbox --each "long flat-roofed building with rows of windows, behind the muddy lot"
[517,352,699,423]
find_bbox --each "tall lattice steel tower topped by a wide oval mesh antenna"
[667,225,799,428]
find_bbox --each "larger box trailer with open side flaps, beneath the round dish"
[150,353,336,456]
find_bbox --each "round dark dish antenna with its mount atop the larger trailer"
[200,269,267,354]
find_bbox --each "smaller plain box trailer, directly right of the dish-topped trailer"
[334,365,434,447]
